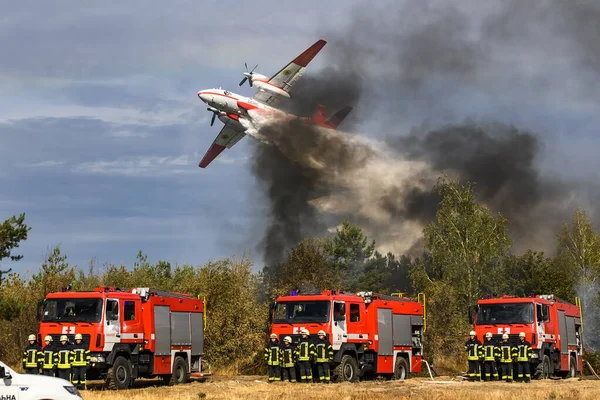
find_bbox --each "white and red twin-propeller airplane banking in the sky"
[198,39,352,168]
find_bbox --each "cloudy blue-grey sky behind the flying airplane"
[0,0,600,272]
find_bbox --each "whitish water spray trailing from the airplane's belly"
[244,111,439,254]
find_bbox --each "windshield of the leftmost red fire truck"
[42,298,102,322]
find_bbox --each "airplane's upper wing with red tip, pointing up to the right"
[253,39,327,105]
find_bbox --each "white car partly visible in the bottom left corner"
[0,361,83,400]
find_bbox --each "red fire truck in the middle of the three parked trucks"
[272,290,425,381]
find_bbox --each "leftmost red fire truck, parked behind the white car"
[39,287,207,389]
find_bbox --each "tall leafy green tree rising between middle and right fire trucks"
[423,180,511,315]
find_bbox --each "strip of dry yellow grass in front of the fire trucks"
[83,376,600,400]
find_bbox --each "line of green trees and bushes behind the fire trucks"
[0,179,600,373]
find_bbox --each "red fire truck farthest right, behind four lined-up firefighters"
[473,295,583,379]
